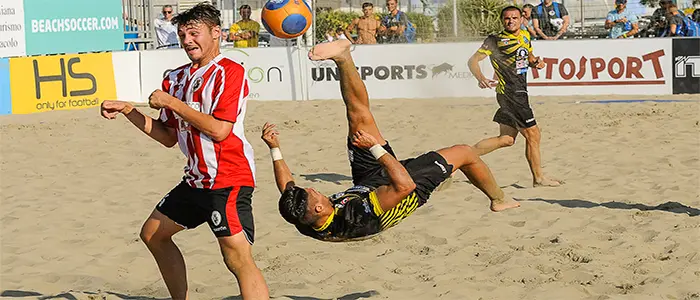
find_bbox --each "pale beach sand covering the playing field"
[0,95,700,300]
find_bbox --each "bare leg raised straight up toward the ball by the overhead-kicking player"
[309,40,386,145]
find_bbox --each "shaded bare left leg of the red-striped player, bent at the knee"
[141,210,188,299]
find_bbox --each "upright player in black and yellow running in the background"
[469,6,562,187]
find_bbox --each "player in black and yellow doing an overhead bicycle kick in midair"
[262,40,520,242]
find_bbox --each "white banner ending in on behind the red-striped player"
[141,47,306,102]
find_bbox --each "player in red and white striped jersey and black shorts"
[101,4,269,299]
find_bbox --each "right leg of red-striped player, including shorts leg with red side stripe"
[208,187,270,299]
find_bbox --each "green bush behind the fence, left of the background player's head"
[437,0,510,38]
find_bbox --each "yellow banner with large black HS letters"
[10,53,117,114]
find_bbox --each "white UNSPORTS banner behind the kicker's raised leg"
[307,43,494,99]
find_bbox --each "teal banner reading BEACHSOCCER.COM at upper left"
[21,0,124,55]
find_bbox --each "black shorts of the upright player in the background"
[493,92,537,129]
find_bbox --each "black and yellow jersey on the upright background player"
[478,30,532,94]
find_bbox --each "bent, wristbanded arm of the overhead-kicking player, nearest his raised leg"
[352,130,416,211]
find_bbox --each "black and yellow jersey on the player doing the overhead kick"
[296,186,420,242]
